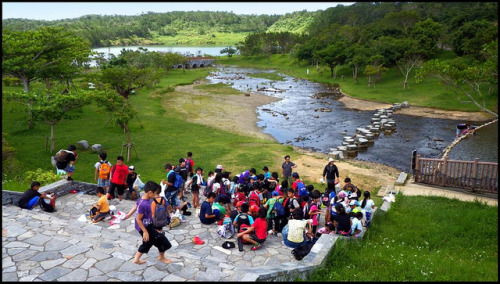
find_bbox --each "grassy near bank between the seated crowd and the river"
[2,69,292,191]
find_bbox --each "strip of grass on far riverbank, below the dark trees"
[217,53,498,112]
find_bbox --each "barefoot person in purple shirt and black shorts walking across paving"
[133,181,172,264]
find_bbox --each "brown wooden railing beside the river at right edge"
[415,155,498,193]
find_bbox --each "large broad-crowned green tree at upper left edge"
[2,27,90,128]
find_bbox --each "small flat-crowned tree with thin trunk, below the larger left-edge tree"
[6,89,90,152]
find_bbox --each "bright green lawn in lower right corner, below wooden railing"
[307,194,498,282]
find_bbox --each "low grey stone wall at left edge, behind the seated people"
[2,179,97,206]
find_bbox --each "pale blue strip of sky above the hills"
[2,2,354,21]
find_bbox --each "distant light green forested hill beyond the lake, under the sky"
[2,11,318,47]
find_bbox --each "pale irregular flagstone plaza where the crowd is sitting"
[2,193,334,281]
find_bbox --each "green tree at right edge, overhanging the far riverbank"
[417,45,498,117]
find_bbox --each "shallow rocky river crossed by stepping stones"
[207,67,498,172]
